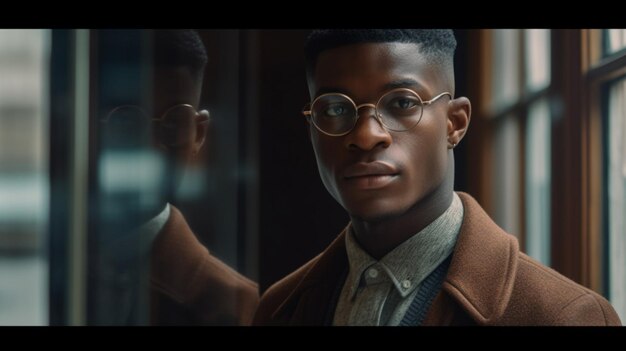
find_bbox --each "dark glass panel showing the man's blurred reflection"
[87,30,256,325]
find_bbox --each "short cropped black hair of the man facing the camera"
[304,29,456,75]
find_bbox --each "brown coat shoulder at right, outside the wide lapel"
[500,253,621,326]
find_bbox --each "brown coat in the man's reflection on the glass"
[151,206,259,325]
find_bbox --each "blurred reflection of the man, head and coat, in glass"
[101,30,258,325]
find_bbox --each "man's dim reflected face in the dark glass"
[100,67,200,220]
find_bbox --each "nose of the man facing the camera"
[345,104,391,151]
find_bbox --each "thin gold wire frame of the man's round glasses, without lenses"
[302,88,454,136]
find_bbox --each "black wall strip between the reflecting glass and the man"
[258,30,348,290]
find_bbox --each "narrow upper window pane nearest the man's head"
[491,29,520,114]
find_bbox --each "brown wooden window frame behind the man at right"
[467,29,626,293]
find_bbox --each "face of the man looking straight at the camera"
[309,43,449,221]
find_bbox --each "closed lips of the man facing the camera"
[343,161,399,189]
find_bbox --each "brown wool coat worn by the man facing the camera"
[253,193,620,325]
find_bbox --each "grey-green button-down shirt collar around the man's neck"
[346,193,463,299]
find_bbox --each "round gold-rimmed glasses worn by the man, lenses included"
[302,88,452,136]
